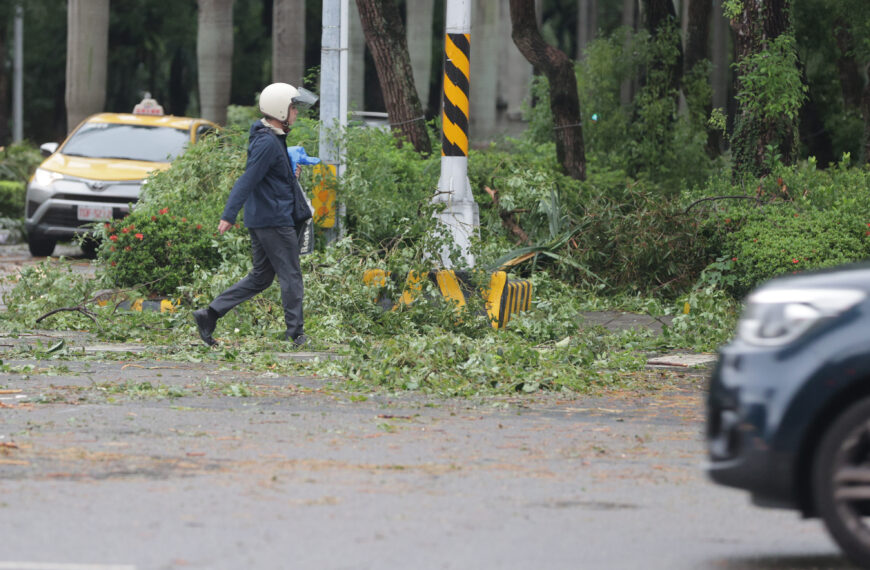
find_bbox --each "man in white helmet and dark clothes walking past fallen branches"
[193,83,317,346]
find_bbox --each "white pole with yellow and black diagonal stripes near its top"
[434,0,480,269]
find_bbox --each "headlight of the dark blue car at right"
[737,289,866,346]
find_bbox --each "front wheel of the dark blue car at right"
[813,398,870,568]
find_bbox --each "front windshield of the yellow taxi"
[61,123,190,162]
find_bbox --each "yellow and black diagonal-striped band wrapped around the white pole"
[441,34,471,156]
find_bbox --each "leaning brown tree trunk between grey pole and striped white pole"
[356,0,432,154]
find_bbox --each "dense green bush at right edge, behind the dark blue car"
[700,156,870,297]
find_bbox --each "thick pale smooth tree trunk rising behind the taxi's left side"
[66,0,109,131]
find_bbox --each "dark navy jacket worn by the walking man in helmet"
[221,120,296,228]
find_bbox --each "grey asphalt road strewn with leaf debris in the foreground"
[0,245,849,570]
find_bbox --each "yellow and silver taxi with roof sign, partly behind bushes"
[25,95,217,256]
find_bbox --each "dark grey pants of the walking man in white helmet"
[209,227,302,339]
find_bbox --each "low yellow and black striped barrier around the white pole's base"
[363,269,532,329]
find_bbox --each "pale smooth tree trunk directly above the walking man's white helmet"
[272,0,305,87]
